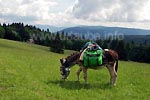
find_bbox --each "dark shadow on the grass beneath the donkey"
[47,80,112,90]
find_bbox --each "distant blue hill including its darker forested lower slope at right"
[59,26,150,44]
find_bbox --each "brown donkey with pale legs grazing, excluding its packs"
[60,49,118,86]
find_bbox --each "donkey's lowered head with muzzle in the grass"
[60,58,70,79]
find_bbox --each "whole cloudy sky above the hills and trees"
[0,0,150,29]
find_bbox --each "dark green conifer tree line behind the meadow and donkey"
[0,23,150,63]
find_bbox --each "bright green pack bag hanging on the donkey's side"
[83,50,102,67]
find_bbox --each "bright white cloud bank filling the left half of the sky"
[0,0,76,26]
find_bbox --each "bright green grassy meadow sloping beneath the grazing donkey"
[0,39,150,100]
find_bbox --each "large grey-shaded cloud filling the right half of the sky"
[72,0,150,22]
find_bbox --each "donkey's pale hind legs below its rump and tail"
[107,63,117,86]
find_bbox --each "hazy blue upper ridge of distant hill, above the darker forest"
[61,26,150,36]
